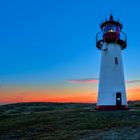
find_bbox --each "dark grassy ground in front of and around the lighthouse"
[0,102,140,140]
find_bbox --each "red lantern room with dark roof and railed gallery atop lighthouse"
[96,15,127,49]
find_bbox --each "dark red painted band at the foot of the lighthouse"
[96,105,128,110]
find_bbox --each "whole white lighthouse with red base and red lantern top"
[96,15,128,110]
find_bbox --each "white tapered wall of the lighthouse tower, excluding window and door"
[97,43,127,106]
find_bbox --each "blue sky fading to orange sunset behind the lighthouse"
[0,0,140,104]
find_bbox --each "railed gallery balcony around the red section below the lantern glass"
[96,31,127,50]
